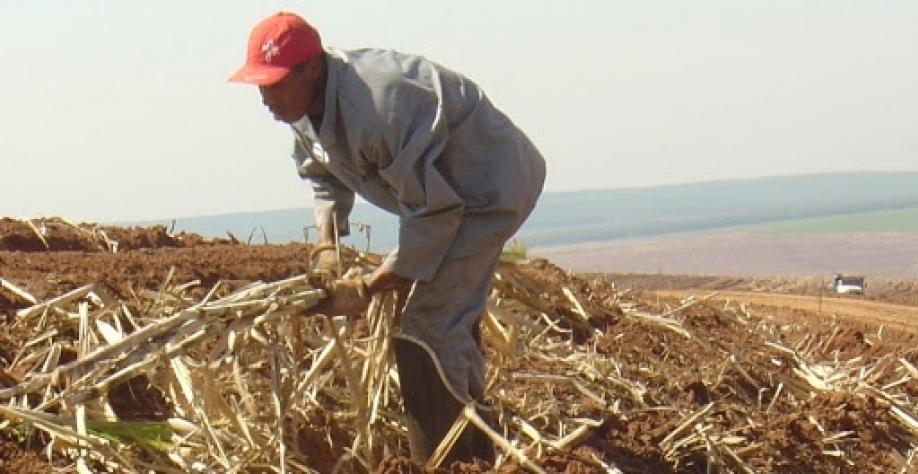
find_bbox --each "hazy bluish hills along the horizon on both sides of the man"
[129,172,918,250]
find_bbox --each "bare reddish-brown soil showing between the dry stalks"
[0,219,918,474]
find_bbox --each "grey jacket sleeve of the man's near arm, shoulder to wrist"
[378,85,465,281]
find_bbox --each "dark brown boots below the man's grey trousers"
[392,337,494,466]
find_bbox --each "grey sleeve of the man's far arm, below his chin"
[293,140,354,237]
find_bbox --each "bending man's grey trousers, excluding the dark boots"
[395,147,545,404]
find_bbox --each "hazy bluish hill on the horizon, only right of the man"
[522,172,918,246]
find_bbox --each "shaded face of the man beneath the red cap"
[258,58,325,123]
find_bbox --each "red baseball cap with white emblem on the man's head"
[229,12,322,86]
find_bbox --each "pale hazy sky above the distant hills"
[0,0,918,222]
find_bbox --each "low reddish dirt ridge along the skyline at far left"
[0,218,239,252]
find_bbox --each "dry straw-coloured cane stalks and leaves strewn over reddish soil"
[0,252,918,473]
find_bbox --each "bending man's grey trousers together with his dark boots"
[393,159,545,462]
